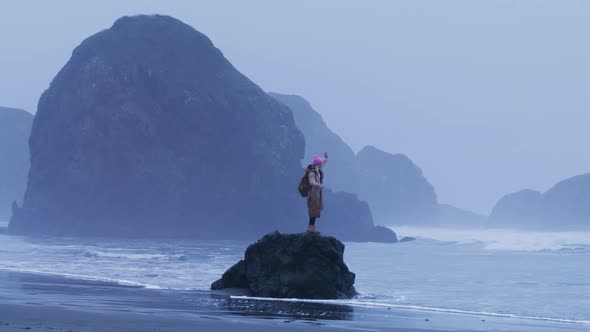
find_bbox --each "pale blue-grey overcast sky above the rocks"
[0,0,590,213]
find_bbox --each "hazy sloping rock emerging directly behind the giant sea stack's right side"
[269,93,359,193]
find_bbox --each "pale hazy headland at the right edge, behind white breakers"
[490,174,590,229]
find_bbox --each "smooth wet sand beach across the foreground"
[0,270,590,332]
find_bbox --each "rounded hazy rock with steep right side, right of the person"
[357,146,439,225]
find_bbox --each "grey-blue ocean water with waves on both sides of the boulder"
[0,227,590,329]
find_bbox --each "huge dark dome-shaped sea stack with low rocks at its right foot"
[9,15,395,242]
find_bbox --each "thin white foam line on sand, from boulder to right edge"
[230,295,590,325]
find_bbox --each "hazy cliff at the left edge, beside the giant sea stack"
[0,107,33,220]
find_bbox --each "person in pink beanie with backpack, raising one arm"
[305,152,328,233]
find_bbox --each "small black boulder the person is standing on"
[211,232,356,299]
